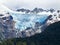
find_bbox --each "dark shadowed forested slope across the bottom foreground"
[0,22,60,45]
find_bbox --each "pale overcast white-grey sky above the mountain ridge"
[0,0,60,10]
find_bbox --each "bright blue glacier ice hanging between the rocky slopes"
[11,13,48,31]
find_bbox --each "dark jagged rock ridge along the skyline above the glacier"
[16,8,55,13]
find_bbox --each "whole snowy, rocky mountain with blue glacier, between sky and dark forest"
[0,5,60,39]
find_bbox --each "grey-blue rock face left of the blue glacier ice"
[0,14,16,39]
